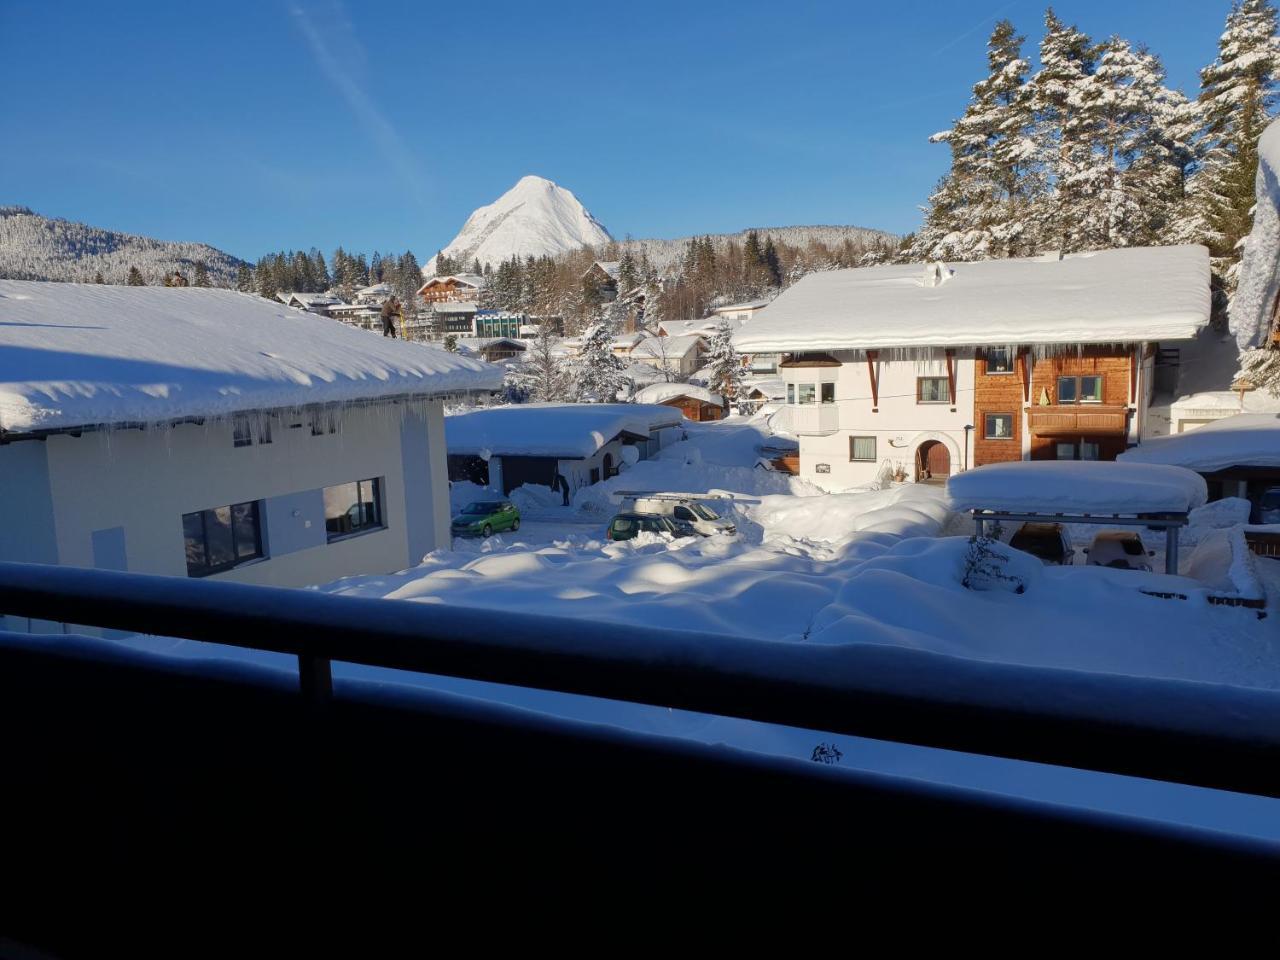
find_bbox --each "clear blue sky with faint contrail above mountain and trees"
[0,0,1229,260]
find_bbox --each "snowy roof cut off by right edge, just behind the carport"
[1120,413,1280,474]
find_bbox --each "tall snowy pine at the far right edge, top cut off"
[1172,0,1280,291]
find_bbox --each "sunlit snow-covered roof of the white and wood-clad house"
[733,246,1210,352]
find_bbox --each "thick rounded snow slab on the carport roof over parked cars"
[947,460,1208,515]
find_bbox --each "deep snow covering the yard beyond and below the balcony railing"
[87,417,1280,838]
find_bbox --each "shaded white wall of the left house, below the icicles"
[0,402,448,586]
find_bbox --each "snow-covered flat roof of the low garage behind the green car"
[444,403,684,460]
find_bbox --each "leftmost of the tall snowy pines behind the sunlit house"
[911,20,1039,260]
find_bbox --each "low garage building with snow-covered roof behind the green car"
[445,403,684,502]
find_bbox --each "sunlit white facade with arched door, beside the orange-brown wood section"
[780,349,974,490]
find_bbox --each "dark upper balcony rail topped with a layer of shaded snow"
[0,562,1280,796]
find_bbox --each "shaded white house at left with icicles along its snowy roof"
[0,280,502,599]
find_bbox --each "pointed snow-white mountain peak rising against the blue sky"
[424,174,613,274]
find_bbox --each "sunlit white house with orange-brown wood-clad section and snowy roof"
[735,246,1210,489]
